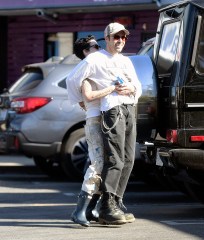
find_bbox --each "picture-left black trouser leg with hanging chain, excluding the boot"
[101,106,126,195]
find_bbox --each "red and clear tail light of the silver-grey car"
[11,97,52,114]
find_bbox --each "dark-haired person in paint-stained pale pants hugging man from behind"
[68,35,116,227]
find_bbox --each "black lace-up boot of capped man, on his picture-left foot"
[99,193,126,225]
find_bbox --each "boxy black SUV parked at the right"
[138,0,204,201]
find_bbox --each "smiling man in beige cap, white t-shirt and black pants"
[67,23,142,224]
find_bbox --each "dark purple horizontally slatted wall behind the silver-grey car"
[7,10,158,86]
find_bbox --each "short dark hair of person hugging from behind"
[74,35,95,59]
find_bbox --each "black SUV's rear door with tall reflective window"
[156,19,182,138]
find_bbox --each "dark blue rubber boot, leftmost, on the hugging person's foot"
[71,190,91,227]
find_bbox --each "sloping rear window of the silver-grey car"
[9,69,43,93]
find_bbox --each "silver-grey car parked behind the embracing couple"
[0,51,156,180]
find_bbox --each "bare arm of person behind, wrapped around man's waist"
[81,80,116,102]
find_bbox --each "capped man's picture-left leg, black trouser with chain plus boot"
[99,107,126,224]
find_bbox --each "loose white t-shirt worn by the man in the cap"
[66,50,142,111]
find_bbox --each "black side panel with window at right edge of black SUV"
[184,15,204,142]
